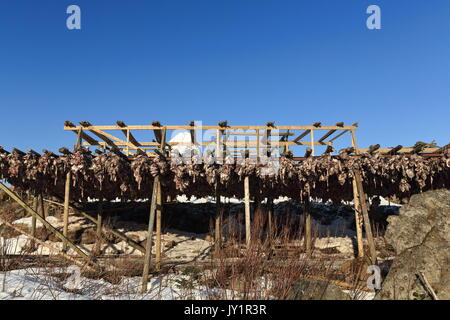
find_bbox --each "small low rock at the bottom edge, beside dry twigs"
[287,279,350,300]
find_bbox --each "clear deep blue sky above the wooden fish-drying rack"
[0,0,450,151]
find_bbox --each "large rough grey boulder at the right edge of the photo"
[375,189,450,299]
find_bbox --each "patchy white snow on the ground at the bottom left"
[0,266,230,300]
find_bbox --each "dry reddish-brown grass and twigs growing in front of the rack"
[0,196,380,299]
